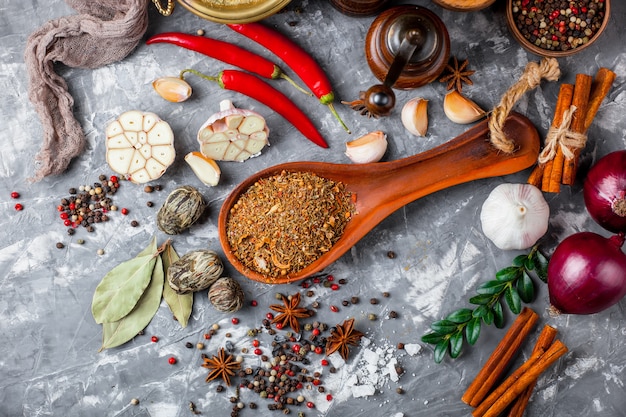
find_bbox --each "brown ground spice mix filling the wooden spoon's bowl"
[226,171,355,278]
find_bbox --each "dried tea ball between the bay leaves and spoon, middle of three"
[167,249,224,294]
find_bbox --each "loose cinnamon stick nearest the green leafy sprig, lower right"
[461,307,539,407]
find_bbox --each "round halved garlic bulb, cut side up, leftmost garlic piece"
[105,110,176,184]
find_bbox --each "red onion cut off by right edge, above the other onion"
[583,150,626,233]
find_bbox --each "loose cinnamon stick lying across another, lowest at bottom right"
[482,340,567,417]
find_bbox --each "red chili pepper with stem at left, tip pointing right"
[180,69,328,148]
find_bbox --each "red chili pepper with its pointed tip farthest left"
[146,32,310,95]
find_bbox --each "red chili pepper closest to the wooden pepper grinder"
[228,22,350,133]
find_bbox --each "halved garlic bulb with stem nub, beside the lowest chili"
[198,100,269,162]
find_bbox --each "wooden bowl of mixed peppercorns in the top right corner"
[506,0,611,58]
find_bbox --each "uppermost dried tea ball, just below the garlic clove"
[157,185,207,235]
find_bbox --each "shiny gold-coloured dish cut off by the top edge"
[178,0,291,23]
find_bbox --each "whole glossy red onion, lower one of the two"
[548,232,626,314]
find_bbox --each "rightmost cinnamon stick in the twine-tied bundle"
[562,68,616,185]
